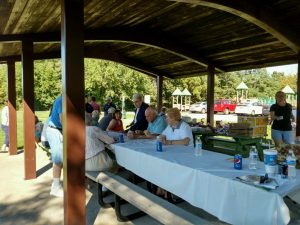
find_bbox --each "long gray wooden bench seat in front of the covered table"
[86,172,210,225]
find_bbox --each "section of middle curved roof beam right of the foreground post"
[85,29,224,72]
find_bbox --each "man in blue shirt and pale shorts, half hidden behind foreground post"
[46,95,64,197]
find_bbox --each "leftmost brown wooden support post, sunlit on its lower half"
[7,61,17,155]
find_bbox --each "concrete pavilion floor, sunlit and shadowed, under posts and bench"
[0,150,300,225]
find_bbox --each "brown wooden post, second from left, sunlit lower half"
[22,40,36,180]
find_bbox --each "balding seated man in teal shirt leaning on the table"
[128,107,167,139]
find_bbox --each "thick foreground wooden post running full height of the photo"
[61,0,86,225]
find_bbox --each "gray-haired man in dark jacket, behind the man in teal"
[127,94,149,133]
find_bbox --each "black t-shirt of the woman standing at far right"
[270,103,293,131]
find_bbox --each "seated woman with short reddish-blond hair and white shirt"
[160,108,194,146]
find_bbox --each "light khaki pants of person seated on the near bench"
[85,151,114,171]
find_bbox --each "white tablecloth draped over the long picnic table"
[112,140,300,225]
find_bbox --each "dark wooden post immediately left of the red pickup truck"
[206,66,215,126]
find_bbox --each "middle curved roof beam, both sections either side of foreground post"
[0,29,224,72]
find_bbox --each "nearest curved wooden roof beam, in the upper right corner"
[168,0,300,53]
